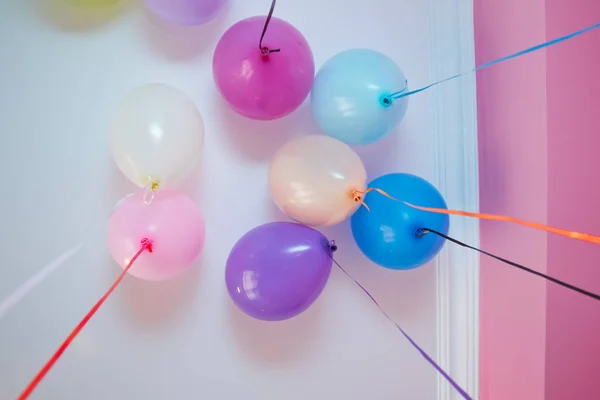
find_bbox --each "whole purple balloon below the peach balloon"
[225,222,333,321]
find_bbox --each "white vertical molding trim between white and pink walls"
[428,0,479,400]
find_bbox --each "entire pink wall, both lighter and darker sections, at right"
[475,0,600,400]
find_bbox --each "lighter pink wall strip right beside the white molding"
[475,0,547,400]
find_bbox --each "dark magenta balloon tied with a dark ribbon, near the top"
[213,16,315,120]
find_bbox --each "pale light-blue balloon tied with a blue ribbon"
[310,49,408,145]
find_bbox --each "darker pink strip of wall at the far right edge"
[546,0,600,400]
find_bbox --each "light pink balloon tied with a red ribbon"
[108,190,205,281]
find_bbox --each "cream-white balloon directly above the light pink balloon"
[110,84,204,187]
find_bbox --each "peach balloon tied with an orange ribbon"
[269,135,367,226]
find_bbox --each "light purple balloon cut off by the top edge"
[144,0,227,26]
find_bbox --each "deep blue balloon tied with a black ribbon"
[352,173,450,269]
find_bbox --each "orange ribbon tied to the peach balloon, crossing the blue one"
[352,188,600,244]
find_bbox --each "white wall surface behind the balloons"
[0,0,476,400]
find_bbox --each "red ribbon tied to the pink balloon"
[18,239,152,400]
